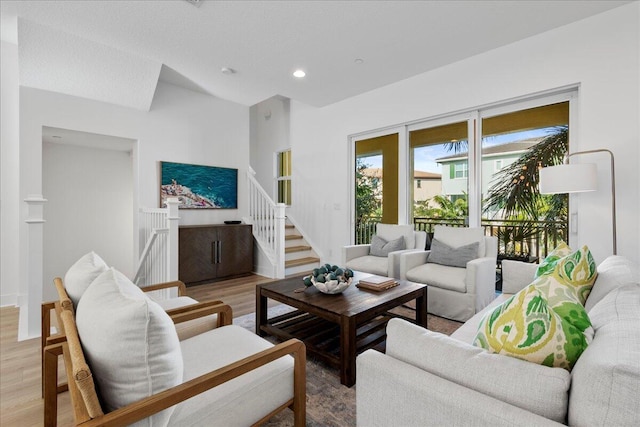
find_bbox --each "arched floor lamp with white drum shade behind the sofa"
[540,149,618,255]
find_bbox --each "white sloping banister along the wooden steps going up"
[247,167,286,278]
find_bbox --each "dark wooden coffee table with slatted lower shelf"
[256,273,427,387]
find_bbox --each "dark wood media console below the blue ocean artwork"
[178,224,253,284]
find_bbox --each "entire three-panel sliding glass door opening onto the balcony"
[352,90,576,261]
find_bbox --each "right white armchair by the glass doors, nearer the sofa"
[400,226,498,322]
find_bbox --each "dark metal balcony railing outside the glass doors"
[356,217,567,259]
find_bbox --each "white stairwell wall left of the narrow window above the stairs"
[251,96,291,196]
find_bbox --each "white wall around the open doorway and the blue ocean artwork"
[11,82,249,337]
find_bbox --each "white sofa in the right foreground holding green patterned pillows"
[356,256,640,427]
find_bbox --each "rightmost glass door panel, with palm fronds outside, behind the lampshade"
[481,102,569,260]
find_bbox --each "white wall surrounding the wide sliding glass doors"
[291,2,640,270]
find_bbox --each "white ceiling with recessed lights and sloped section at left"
[0,0,637,110]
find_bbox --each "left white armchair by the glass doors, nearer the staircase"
[342,224,427,279]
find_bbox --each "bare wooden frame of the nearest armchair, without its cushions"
[43,276,306,427]
